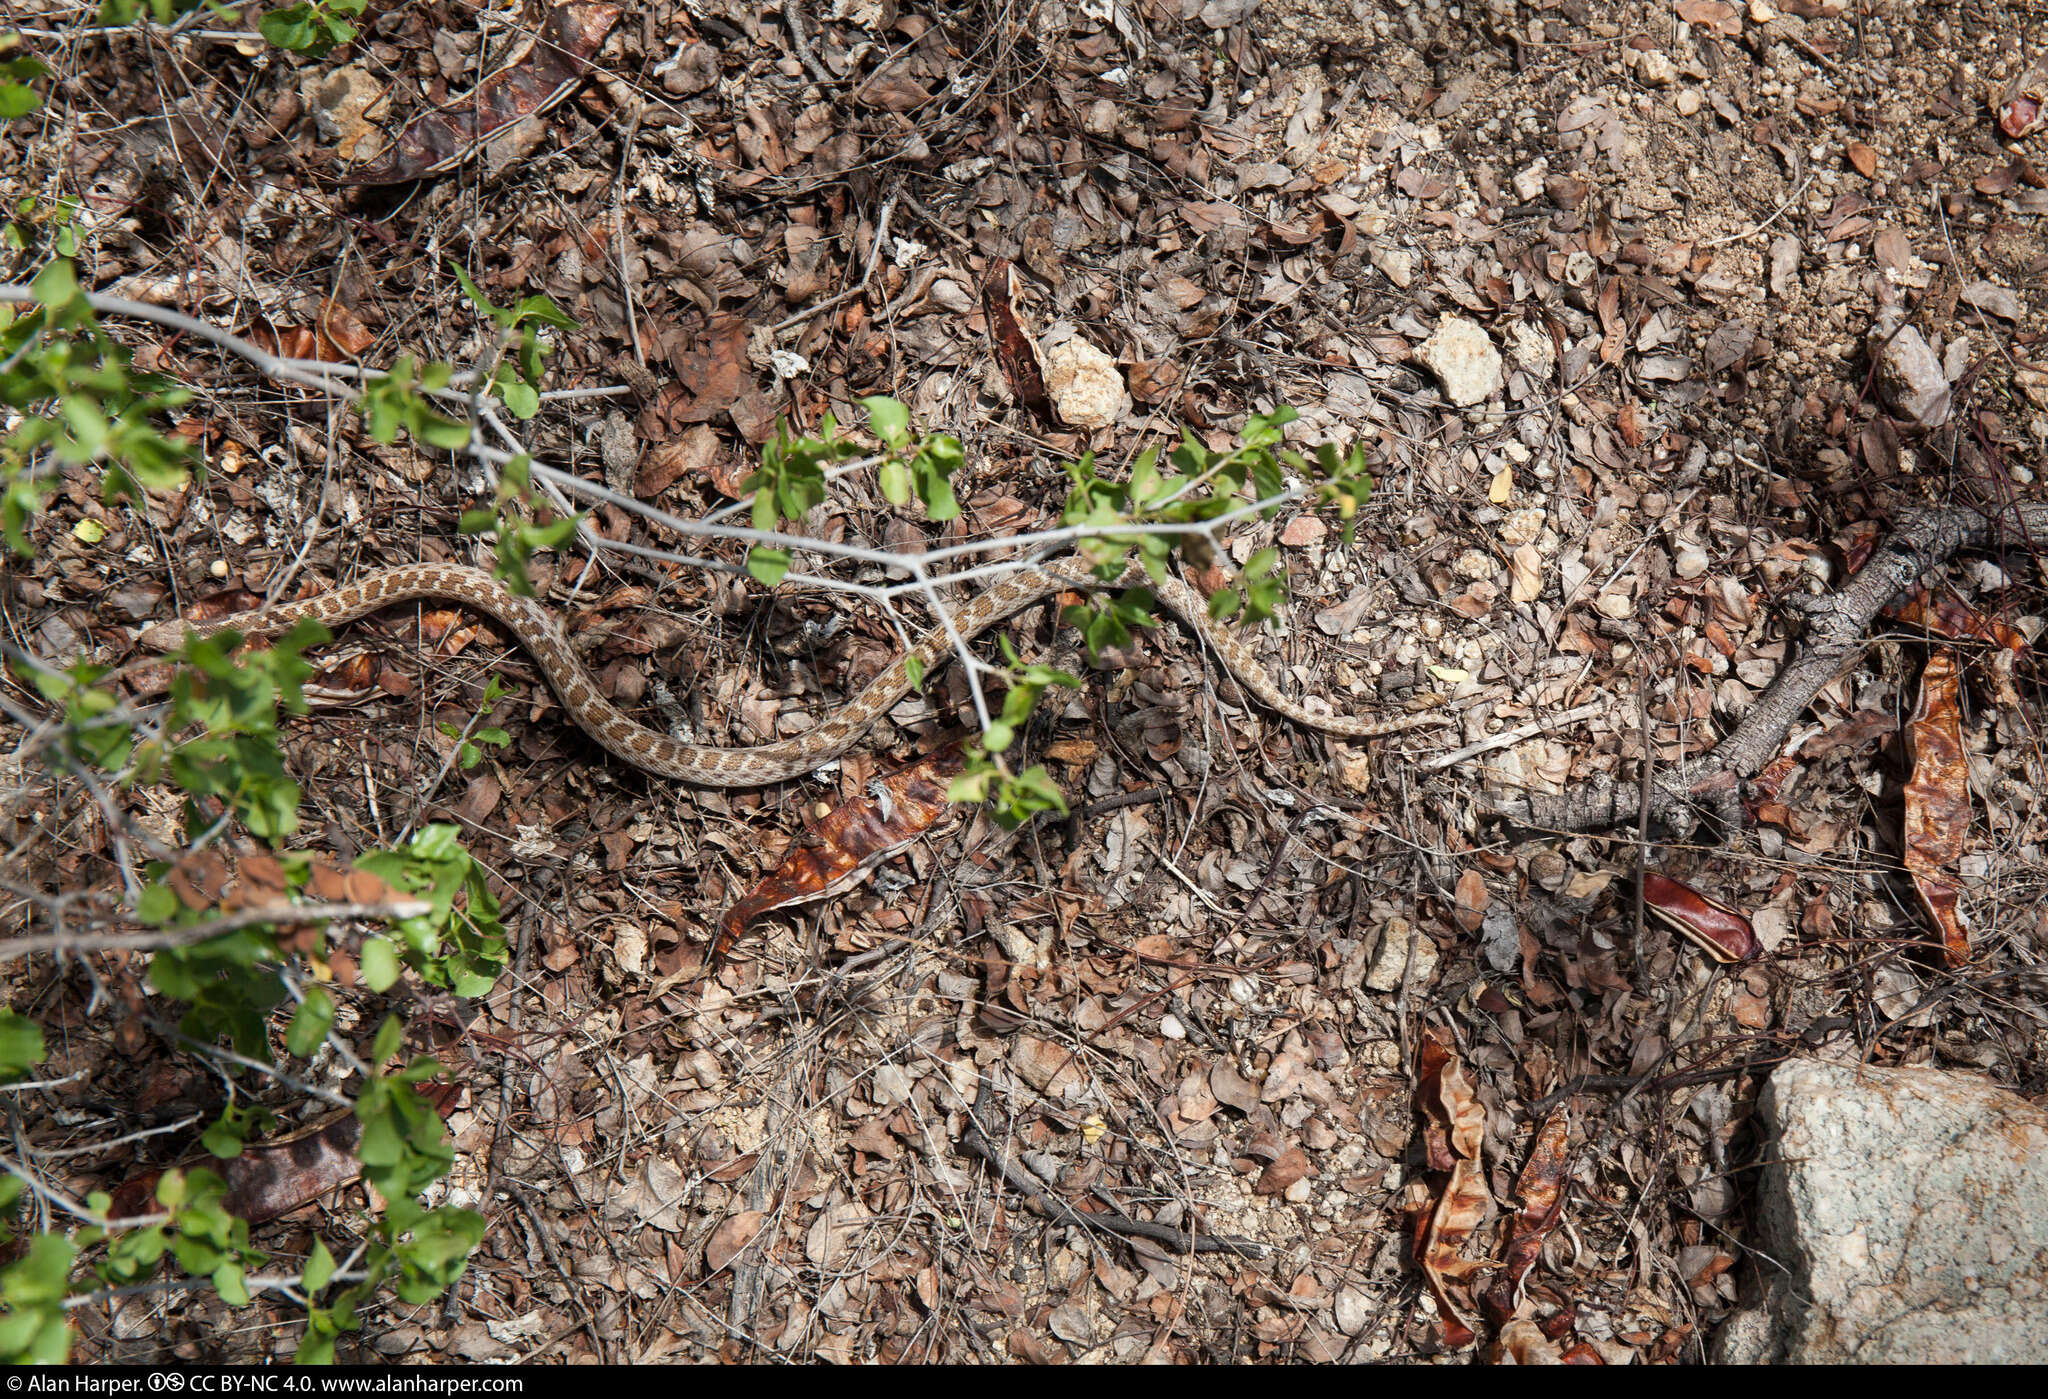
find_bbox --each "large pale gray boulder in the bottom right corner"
[1716,1059,2048,1364]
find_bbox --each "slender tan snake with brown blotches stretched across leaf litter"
[137,555,1448,787]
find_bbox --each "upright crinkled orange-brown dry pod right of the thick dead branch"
[1905,647,1970,967]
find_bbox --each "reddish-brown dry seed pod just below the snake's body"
[707,741,965,971]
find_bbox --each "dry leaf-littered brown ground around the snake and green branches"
[0,0,2048,1364]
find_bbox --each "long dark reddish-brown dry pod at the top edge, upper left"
[342,0,625,184]
